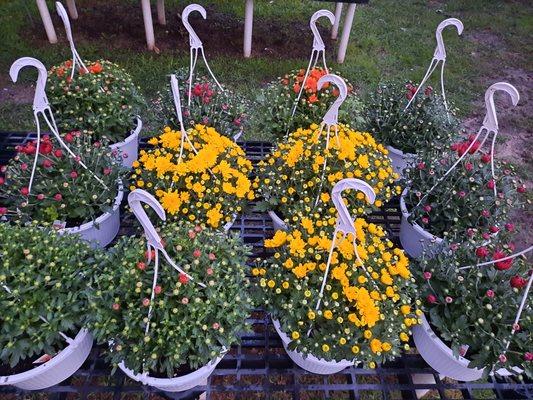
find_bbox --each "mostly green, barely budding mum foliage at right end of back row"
[365,83,459,153]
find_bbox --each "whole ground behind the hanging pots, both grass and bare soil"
[0,0,533,236]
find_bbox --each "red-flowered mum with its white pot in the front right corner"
[413,233,533,381]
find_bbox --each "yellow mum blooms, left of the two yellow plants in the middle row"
[130,125,254,228]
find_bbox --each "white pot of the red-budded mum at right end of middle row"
[400,188,443,258]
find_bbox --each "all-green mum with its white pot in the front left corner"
[0,223,102,390]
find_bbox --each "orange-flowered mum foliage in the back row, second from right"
[251,67,364,140]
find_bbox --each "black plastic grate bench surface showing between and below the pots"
[0,132,533,400]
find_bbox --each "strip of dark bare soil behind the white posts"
[27,0,334,58]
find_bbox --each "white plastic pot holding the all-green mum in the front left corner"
[0,329,93,390]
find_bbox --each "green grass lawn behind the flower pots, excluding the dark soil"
[0,0,533,134]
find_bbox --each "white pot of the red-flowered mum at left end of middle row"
[59,183,124,247]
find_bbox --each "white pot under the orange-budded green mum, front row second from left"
[118,355,224,392]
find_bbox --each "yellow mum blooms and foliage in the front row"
[252,217,421,368]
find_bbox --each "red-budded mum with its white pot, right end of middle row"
[400,137,526,258]
